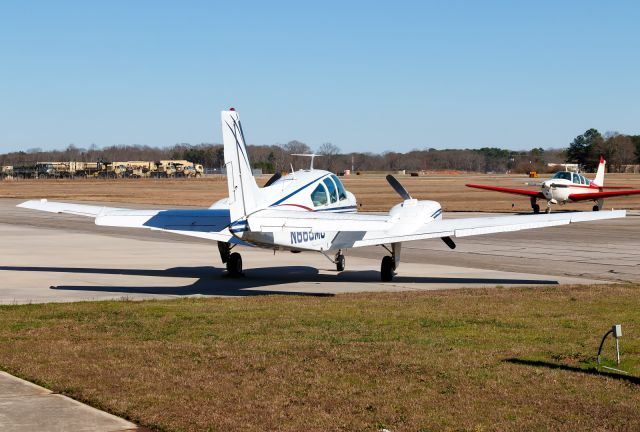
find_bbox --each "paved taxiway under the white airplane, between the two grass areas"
[0,199,640,304]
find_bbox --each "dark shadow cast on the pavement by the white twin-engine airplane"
[0,266,558,296]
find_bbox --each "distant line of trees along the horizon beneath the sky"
[0,129,640,173]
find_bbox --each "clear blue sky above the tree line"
[0,0,640,152]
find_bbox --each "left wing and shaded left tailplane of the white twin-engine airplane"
[18,200,245,244]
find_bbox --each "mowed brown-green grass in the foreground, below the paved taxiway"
[0,285,640,431]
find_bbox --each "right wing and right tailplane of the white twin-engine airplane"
[247,205,626,248]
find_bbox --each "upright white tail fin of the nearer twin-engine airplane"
[221,108,260,222]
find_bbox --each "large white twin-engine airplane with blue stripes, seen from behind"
[19,109,626,281]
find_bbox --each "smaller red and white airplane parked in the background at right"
[466,157,640,213]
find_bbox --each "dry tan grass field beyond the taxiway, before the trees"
[0,174,640,212]
